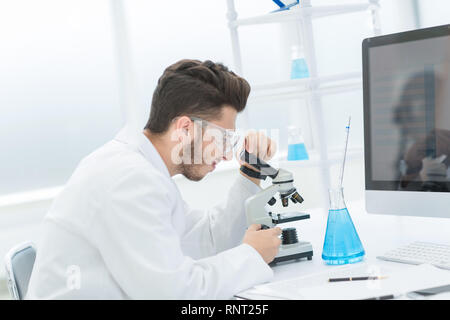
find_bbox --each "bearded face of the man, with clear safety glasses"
[180,106,237,181]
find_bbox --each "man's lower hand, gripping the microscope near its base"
[242,224,281,263]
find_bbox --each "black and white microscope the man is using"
[240,150,313,265]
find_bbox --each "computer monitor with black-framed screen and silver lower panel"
[362,25,450,218]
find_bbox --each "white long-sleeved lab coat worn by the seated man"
[27,130,273,299]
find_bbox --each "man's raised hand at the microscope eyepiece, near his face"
[237,131,277,185]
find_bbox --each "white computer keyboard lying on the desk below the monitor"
[377,241,450,270]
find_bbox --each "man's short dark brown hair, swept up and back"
[145,59,250,133]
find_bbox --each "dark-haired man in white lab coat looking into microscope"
[27,60,281,299]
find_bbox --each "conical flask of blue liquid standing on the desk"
[322,188,365,265]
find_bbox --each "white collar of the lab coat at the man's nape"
[114,127,170,178]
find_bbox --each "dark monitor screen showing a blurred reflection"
[366,34,450,192]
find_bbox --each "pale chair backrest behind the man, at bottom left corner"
[5,242,36,300]
